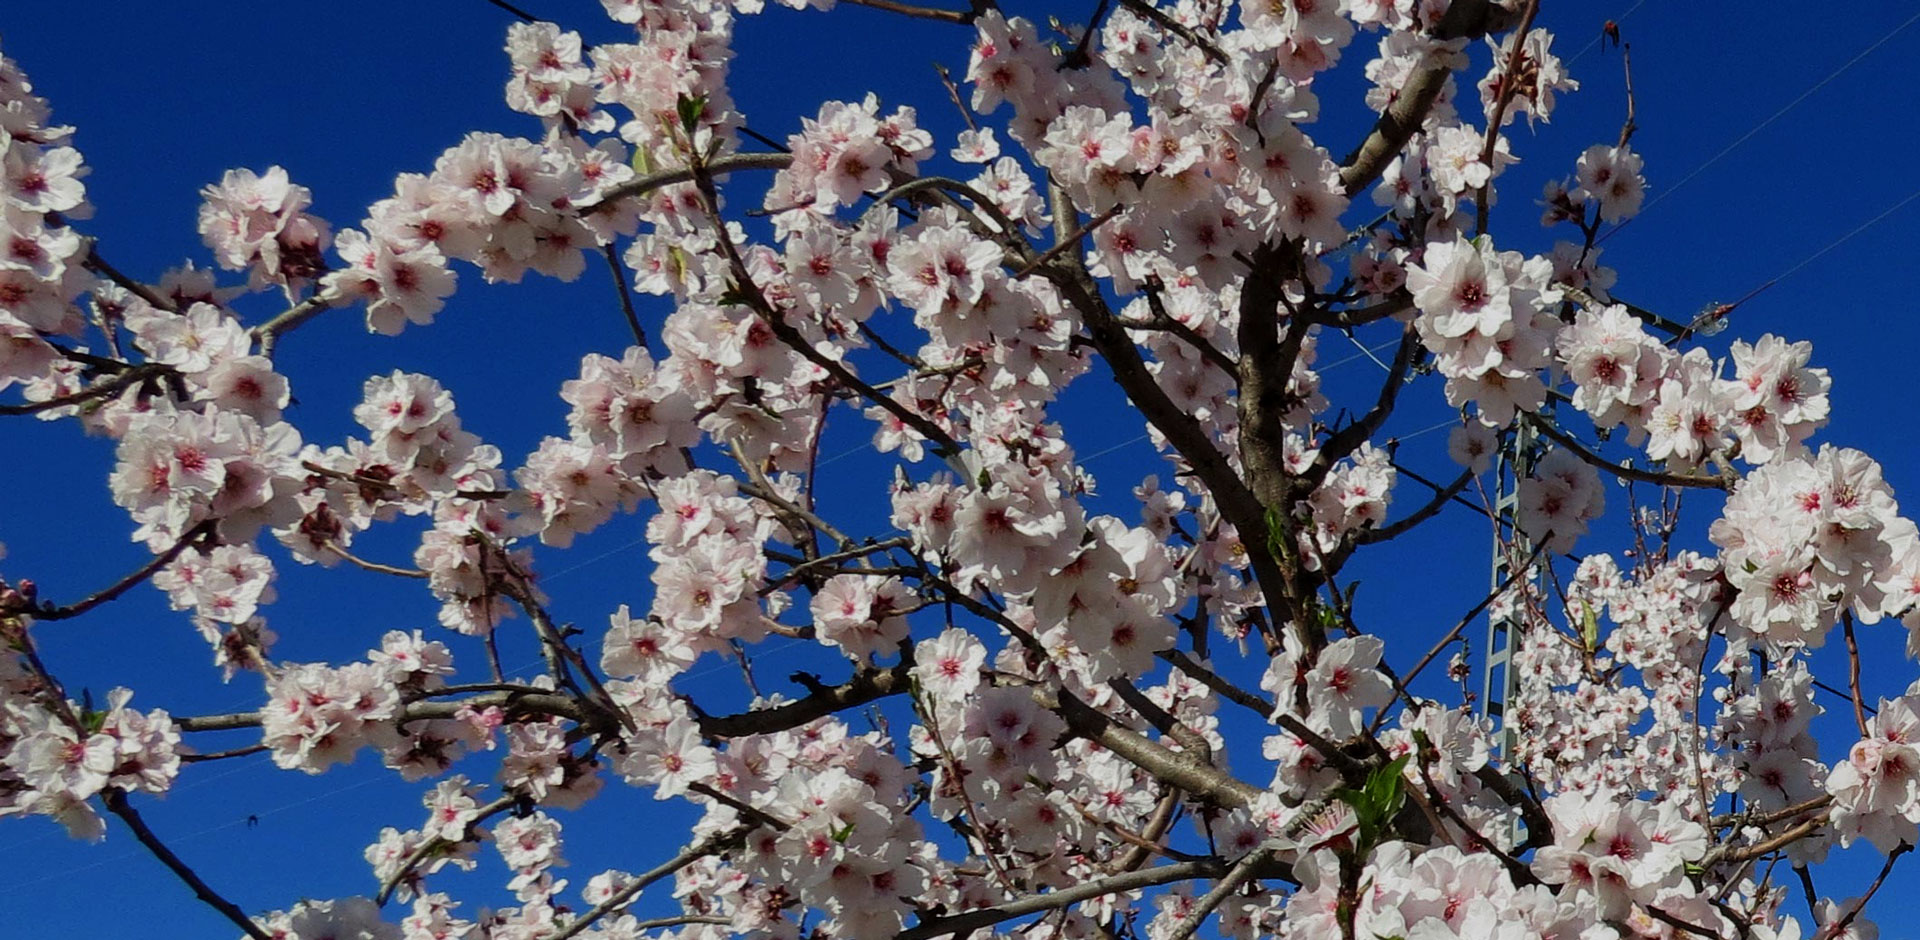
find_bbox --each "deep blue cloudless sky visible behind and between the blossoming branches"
[0,0,1920,938]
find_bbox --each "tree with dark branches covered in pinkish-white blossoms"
[0,0,1920,940]
